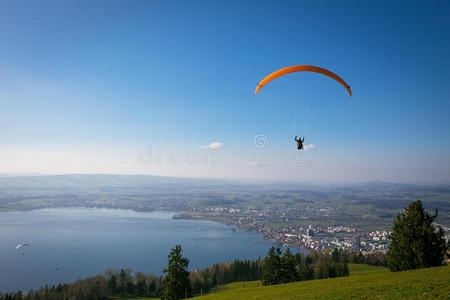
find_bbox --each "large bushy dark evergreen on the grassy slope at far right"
[388,200,447,271]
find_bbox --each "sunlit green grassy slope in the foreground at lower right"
[198,265,450,299]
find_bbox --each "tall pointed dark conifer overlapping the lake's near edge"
[162,245,192,300]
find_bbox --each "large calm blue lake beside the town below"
[0,208,301,292]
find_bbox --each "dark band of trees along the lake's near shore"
[0,245,366,300]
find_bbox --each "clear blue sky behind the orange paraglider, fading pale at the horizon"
[0,1,450,182]
